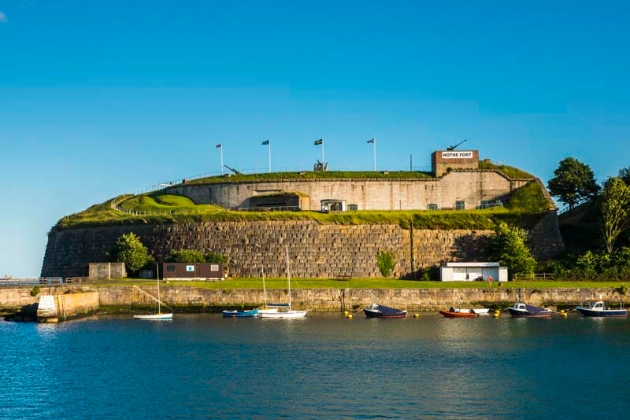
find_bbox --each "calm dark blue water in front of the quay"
[0,314,630,419]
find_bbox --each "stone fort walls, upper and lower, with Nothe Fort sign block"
[42,150,564,278]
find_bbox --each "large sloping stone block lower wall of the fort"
[42,211,564,278]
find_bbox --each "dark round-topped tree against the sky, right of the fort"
[547,157,600,211]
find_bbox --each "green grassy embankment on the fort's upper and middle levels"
[55,163,549,229]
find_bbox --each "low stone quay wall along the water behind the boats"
[0,284,623,317]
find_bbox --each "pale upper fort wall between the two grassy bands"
[165,169,536,211]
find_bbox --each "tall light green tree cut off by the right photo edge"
[601,177,630,254]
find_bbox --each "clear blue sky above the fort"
[0,0,630,277]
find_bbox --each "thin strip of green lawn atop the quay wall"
[98,278,621,290]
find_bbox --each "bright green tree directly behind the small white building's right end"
[486,223,536,276]
